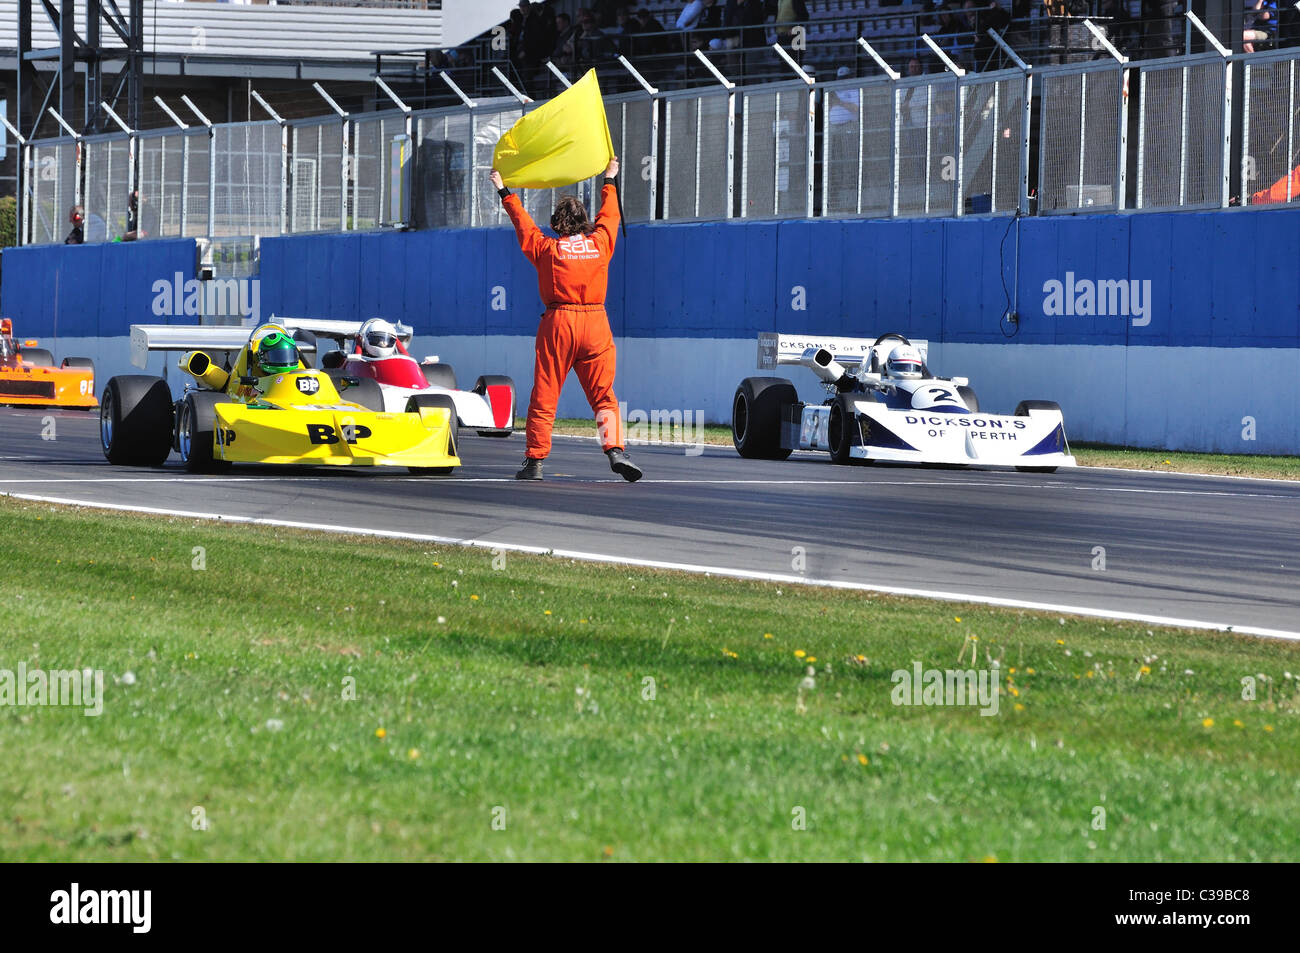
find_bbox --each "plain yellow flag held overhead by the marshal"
[491,69,614,189]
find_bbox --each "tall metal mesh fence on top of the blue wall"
[21,49,1300,243]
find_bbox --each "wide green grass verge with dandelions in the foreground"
[0,499,1300,861]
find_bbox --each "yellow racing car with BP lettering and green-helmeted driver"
[100,324,460,475]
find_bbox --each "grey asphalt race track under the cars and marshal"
[0,410,1300,637]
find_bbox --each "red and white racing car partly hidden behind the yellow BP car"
[273,317,515,437]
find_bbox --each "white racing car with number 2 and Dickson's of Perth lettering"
[732,333,1075,473]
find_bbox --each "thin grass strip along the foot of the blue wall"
[533,417,1300,480]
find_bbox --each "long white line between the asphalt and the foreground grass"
[10,491,1300,641]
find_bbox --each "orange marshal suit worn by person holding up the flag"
[502,185,623,460]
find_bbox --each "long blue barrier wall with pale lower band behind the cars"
[0,208,1300,452]
